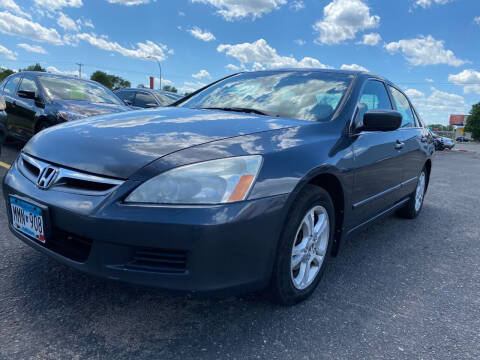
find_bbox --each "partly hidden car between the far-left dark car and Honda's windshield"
[115,88,183,109]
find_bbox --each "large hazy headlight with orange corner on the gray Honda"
[125,155,262,204]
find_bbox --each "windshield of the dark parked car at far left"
[38,75,121,104]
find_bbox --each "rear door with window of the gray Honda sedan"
[389,85,428,200]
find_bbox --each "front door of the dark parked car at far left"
[16,75,40,138]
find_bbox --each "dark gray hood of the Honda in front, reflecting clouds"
[23,107,311,179]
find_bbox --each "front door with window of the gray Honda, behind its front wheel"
[351,79,403,226]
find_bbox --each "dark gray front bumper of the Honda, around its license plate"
[3,163,287,294]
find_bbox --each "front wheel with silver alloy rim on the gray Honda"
[270,185,335,305]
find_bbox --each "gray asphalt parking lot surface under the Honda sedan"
[0,144,480,360]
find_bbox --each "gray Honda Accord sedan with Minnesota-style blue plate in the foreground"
[3,69,434,304]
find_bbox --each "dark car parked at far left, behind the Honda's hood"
[0,71,131,140]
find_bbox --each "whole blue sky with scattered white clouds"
[0,0,480,123]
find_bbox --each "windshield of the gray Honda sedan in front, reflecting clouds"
[179,71,353,121]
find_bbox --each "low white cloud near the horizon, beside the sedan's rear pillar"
[405,87,468,124]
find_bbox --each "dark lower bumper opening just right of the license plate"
[46,228,93,262]
